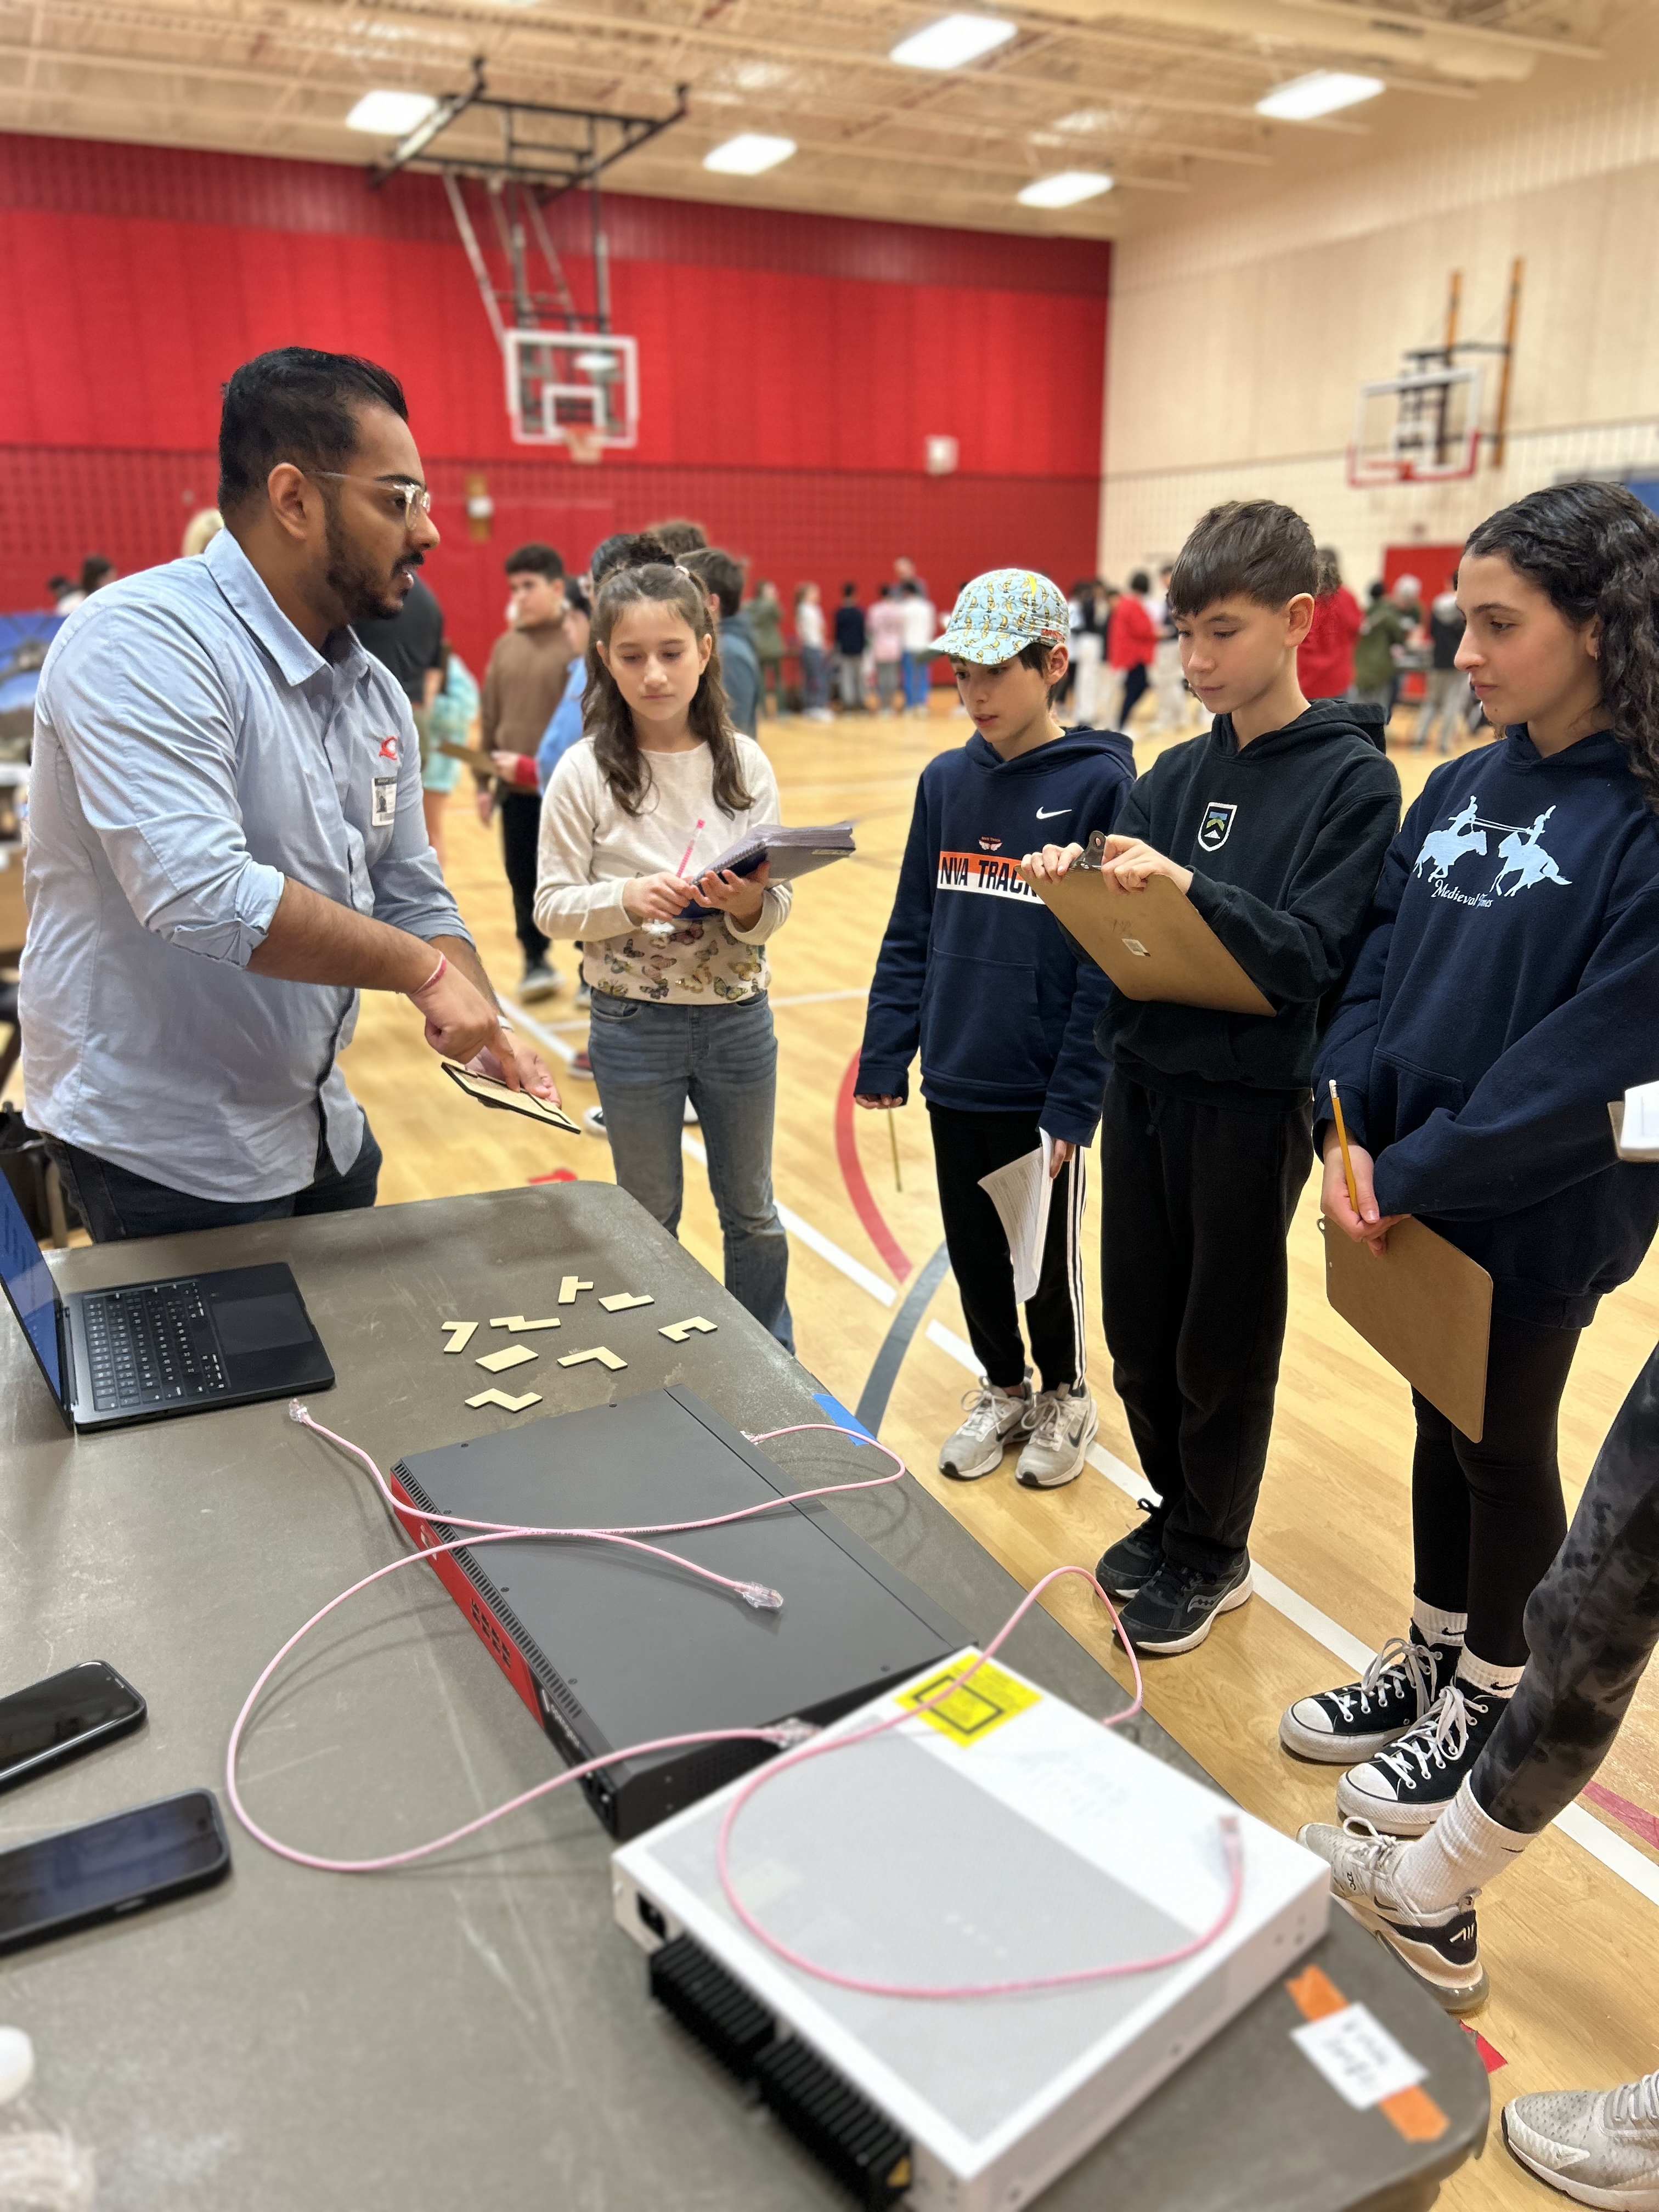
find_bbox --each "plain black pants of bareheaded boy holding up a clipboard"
[1099,1068,1314,1575]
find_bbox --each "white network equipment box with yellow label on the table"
[611,1650,1329,2212]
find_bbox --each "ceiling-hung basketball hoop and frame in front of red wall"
[369,58,688,462]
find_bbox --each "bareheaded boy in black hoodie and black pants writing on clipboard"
[1029,500,1400,1655]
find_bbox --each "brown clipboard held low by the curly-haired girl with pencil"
[1321,1217,1491,1444]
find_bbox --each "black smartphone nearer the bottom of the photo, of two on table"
[0,1790,230,1951]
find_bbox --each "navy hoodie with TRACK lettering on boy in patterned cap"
[858,730,1135,1144]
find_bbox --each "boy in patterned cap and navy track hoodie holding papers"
[856,568,1135,1489]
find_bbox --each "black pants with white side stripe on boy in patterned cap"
[927,1104,1084,1389]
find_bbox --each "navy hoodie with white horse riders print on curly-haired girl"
[1316,728,1659,1329]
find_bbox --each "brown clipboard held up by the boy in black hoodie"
[1031,832,1274,1015]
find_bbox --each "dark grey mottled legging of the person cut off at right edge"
[1469,1350,1659,1836]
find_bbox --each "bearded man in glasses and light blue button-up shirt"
[20,347,557,1241]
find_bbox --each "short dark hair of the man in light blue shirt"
[219,345,409,513]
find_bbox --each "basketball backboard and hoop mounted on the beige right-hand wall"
[1347,257,1522,491]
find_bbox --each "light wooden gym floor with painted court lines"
[22,695,1659,2212]
